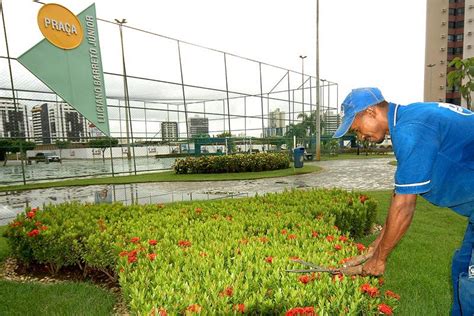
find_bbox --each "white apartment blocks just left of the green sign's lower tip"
[31,103,89,144]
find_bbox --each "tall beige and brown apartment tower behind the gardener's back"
[424,0,474,105]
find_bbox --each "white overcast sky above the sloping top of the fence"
[1,0,426,136]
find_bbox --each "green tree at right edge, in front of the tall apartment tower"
[448,57,474,110]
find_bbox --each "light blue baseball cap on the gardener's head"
[332,88,385,138]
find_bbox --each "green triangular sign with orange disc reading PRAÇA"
[18,4,110,136]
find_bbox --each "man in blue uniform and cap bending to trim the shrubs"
[334,88,474,315]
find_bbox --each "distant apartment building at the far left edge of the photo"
[0,101,29,139]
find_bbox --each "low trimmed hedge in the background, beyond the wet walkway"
[173,153,290,174]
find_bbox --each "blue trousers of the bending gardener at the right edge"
[451,216,474,316]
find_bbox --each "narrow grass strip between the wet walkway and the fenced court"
[0,165,321,192]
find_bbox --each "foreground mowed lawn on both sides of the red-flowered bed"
[0,191,467,315]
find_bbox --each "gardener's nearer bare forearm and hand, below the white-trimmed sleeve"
[362,194,417,275]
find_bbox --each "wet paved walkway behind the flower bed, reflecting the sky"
[0,157,396,225]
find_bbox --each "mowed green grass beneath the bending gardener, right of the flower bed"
[361,191,467,315]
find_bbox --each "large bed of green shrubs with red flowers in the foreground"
[7,190,397,315]
